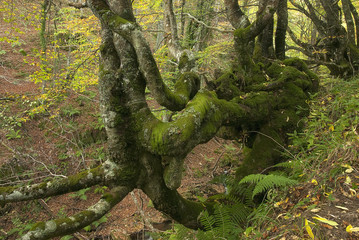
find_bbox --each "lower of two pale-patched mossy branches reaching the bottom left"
[21,187,132,240]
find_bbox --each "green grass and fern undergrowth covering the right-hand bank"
[154,77,359,240]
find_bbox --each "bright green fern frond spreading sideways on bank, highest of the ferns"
[239,174,298,199]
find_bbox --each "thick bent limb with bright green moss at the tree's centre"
[136,90,247,156]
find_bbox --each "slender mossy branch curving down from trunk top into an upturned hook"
[89,1,199,111]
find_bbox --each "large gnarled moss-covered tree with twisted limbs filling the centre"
[0,0,318,239]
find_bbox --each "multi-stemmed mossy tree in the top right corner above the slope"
[288,0,359,77]
